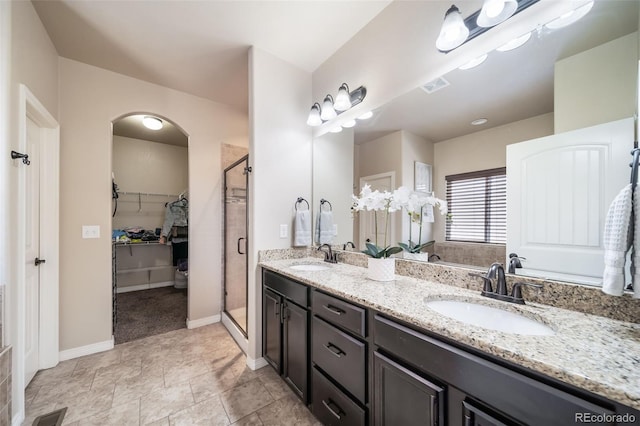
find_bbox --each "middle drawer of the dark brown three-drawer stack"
[313,317,367,403]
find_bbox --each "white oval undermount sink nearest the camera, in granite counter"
[426,300,555,336]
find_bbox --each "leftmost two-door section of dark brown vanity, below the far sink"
[262,270,309,404]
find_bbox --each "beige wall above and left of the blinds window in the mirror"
[433,113,553,242]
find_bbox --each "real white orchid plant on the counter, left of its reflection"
[352,185,402,259]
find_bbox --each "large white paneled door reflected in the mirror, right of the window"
[507,118,633,284]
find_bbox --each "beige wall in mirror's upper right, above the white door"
[554,32,638,133]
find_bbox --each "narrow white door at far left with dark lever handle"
[24,118,44,387]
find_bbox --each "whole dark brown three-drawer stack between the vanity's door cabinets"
[311,290,368,426]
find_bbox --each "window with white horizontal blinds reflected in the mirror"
[445,167,507,244]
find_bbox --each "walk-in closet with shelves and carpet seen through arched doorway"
[112,114,189,344]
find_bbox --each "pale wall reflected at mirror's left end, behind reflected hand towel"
[309,129,354,244]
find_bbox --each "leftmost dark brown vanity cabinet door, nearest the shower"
[262,288,282,374]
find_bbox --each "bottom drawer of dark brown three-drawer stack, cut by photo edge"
[311,368,365,426]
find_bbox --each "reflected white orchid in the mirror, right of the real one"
[393,186,447,253]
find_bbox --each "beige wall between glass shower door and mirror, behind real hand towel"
[247,48,312,363]
